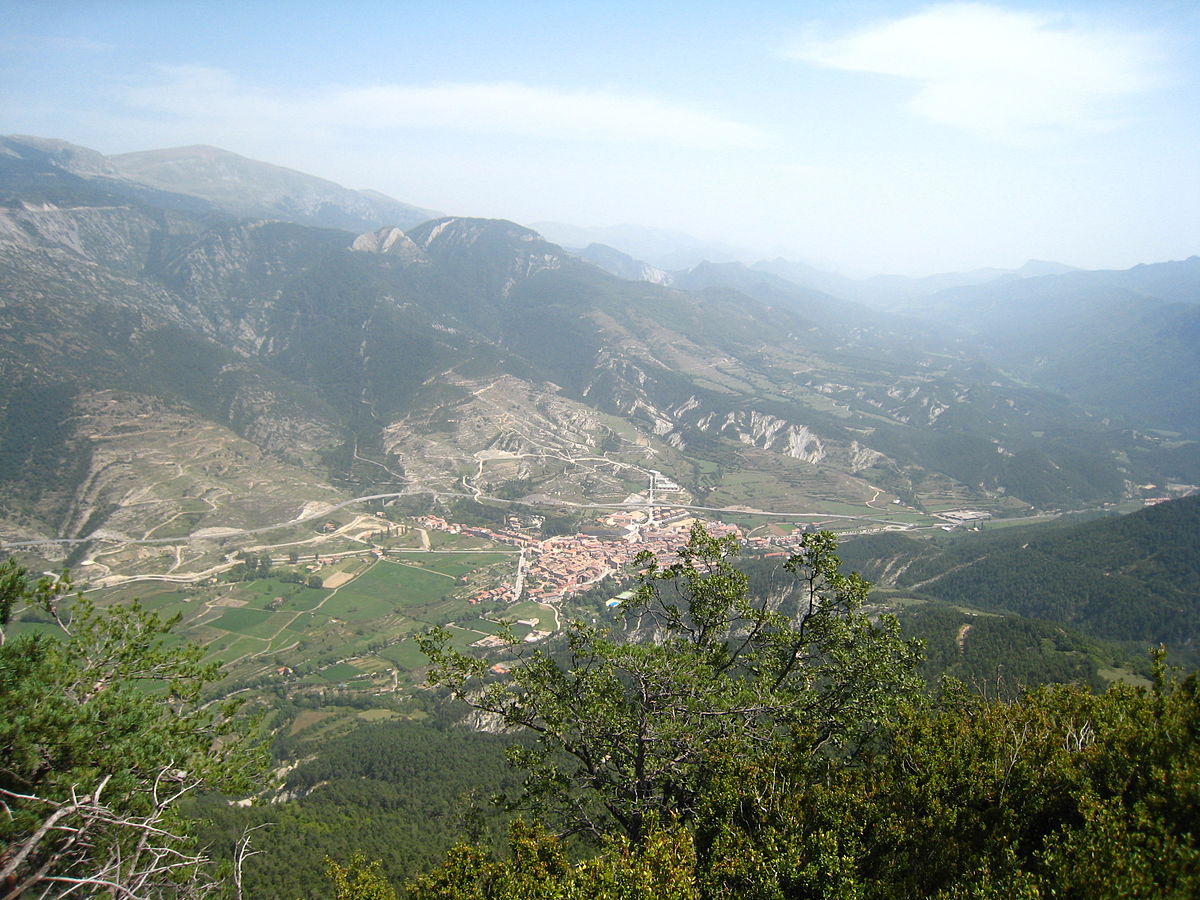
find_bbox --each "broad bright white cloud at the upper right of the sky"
[791,4,1159,143]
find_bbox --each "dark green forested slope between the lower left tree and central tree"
[187,720,520,900]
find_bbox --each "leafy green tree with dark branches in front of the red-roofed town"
[422,524,919,846]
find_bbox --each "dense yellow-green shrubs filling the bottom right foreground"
[409,677,1200,900]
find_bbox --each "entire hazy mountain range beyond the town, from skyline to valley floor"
[0,137,1200,554]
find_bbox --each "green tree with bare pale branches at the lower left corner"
[0,562,264,896]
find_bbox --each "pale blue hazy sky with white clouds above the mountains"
[0,0,1200,274]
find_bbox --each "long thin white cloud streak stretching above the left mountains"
[119,66,766,149]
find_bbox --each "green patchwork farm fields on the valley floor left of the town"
[13,549,525,691]
